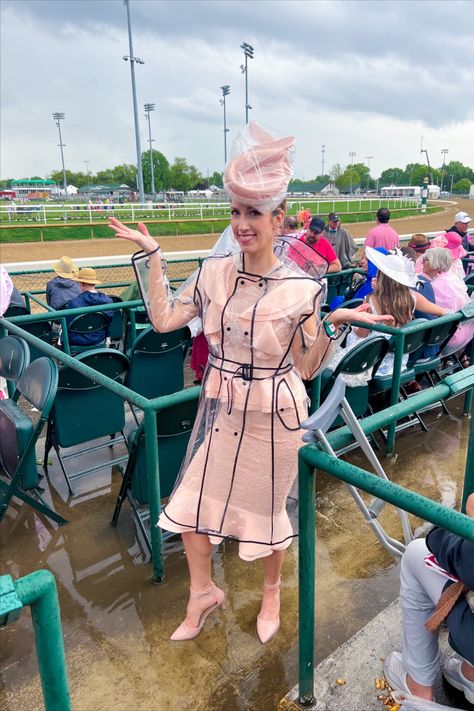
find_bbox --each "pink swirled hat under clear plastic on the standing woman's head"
[224,122,295,212]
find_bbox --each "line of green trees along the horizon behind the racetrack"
[0,150,474,194]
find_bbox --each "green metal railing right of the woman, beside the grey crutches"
[298,366,474,705]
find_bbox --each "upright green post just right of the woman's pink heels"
[298,456,316,704]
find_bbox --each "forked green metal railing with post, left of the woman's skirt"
[0,318,201,582]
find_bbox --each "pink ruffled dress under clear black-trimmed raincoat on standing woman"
[131,253,335,560]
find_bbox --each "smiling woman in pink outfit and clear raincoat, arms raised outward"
[110,123,390,643]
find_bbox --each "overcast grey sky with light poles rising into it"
[1,0,474,179]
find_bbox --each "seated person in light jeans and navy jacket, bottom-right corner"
[384,493,474,704]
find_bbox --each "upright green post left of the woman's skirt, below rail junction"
[145,409,165,583]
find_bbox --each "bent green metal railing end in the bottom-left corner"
[0,570,71,711]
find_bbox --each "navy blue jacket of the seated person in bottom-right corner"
[426,527,474,664]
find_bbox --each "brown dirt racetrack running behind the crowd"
[0,200,474,263]
